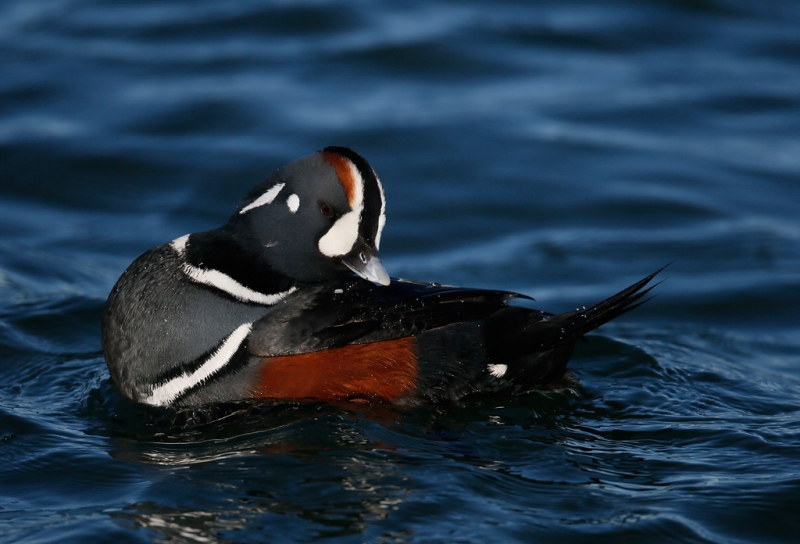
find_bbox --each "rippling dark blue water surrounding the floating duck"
[0,0,800,543]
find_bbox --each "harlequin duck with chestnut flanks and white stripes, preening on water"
[103,147,658,406]
